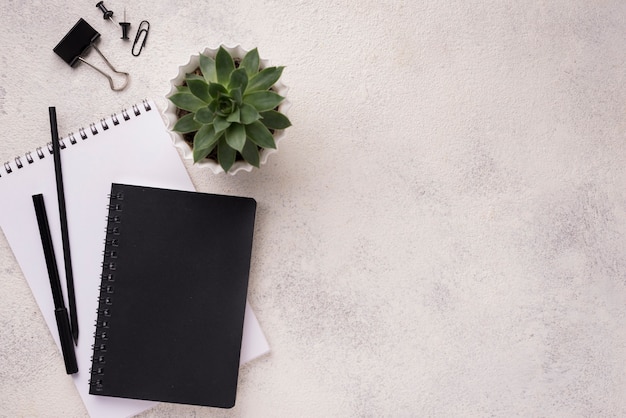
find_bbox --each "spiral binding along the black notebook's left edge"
[89,189,124,393]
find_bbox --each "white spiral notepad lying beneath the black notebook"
[0,101,269,417]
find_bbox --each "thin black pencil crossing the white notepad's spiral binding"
[48,107,78,344]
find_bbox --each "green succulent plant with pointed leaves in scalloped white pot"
[169,47,291,172]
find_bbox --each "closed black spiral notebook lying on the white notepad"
[89,184,256,408]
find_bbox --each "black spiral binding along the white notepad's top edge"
[0,99,152,178]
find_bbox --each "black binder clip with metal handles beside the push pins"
[54,18,130,91]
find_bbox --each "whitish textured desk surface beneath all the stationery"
[0,0,626,417]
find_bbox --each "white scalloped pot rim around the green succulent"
[164,45,290,175]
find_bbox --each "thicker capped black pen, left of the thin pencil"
[33,194,78,374]
